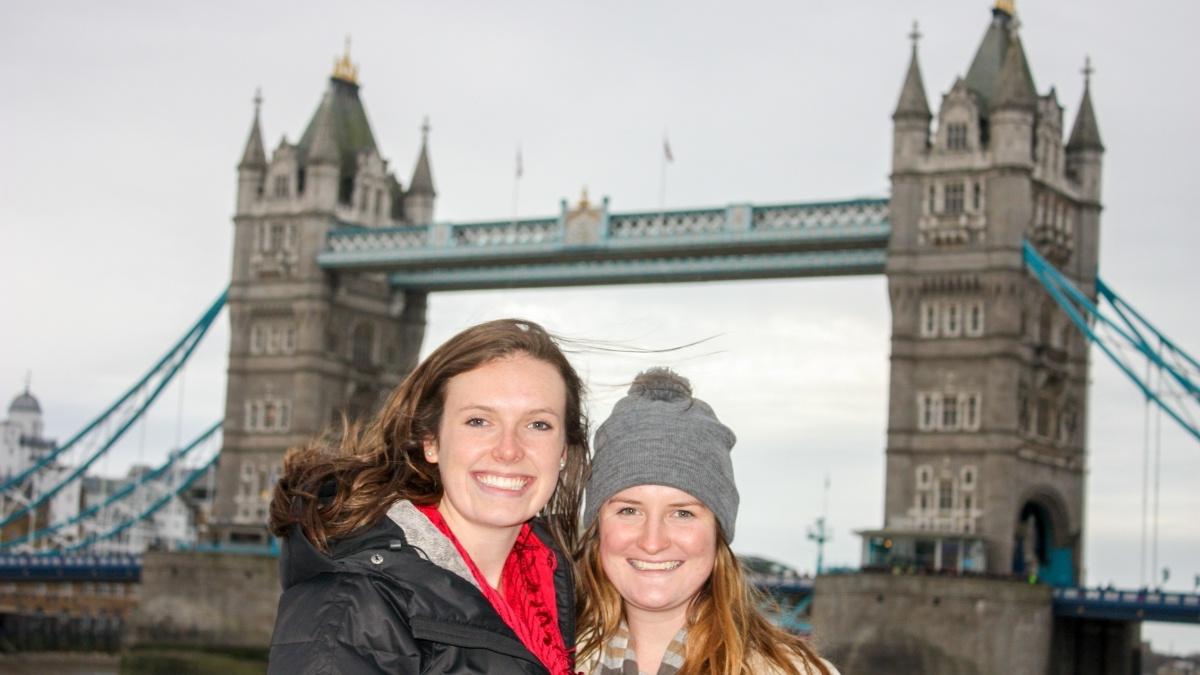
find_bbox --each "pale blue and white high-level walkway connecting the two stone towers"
[317,198,892,291]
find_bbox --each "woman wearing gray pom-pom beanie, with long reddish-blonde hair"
[576,369,836,675]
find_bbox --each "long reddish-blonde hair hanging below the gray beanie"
[576,519,829,675]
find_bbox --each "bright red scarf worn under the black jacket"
[416,506,571,675]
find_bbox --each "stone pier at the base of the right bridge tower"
[812,573,1141,675]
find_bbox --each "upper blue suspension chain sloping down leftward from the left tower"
[0,291,228,528]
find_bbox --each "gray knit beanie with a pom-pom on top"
[583,368,738,542]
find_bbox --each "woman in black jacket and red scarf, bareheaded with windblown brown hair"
[270,319,589,675]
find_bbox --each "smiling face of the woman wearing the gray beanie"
[599,485,716,626]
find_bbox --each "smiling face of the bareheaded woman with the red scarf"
[425,353,566,549]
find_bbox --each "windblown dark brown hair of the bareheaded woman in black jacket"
[270,318,590,551]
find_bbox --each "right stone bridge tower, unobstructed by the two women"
[864,0,1104,584]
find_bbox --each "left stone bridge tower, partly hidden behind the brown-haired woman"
[214,46,434,544]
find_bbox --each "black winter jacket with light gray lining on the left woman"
[269,501,575,675]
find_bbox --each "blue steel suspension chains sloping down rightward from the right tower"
[1022,241,1200,441]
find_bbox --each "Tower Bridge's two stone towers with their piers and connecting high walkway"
[5,2,1200,673]
